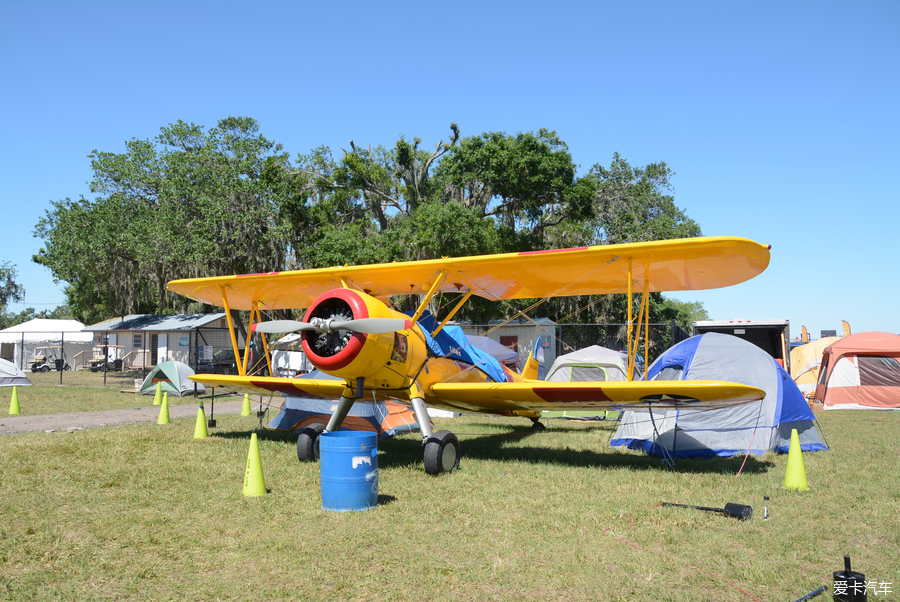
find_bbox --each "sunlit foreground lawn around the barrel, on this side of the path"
[0,412,900,600]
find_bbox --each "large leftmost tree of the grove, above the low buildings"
[34,117,305,321]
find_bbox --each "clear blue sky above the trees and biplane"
[0,0,900,336]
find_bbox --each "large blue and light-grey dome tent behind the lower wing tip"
[610,332,828,457]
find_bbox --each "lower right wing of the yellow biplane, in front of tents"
[426,380,766,411]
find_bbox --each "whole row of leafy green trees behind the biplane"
[34,117,700,322]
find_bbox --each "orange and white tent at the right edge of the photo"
[816,332,900,410]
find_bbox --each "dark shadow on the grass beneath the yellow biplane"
[210,423,774,474]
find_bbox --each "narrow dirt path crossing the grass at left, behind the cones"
[0,400,250,435]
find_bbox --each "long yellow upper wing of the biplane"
[168,236,769,309]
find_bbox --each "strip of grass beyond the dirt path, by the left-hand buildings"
[7,370,236,416]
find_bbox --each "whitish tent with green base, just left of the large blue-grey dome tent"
[541,345,628,419]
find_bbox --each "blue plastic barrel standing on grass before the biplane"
[319,431,378,512]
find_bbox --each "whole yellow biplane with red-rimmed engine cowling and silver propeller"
[168,237,769,474]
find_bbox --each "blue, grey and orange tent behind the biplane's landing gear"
[269,370,419,436]
